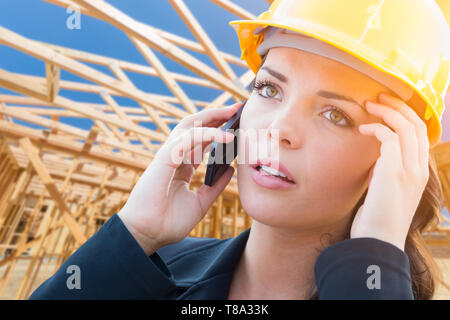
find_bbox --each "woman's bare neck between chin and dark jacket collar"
[229,221,343,300]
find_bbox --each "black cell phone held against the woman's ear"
[205,101,247,186]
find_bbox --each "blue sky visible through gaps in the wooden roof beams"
[0,0,268,129]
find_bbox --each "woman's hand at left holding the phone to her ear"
[118,102,242,255]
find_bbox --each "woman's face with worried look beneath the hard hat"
[237,48,395,230]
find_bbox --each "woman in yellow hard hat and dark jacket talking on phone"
[31,0,449,299]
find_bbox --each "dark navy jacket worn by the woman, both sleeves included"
[29,214,413,300]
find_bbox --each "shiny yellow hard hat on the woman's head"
[229,0,450,147]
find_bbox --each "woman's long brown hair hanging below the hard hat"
[249,54,444,300]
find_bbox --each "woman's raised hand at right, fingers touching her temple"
[350,94,429,250]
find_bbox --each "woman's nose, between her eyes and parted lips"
[268,107,300,149]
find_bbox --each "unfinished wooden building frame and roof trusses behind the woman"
[0,0,450,299]
